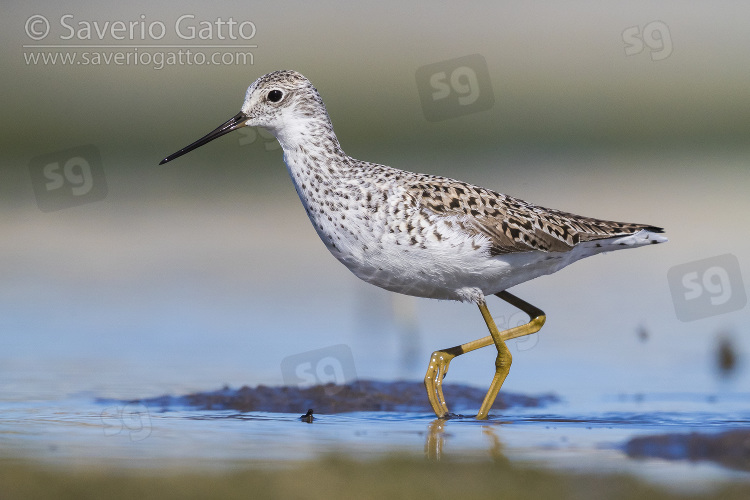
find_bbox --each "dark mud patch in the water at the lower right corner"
[625,429,750,471]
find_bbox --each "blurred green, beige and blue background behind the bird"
[0,1,750,400]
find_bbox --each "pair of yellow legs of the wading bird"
[424,292,545,419]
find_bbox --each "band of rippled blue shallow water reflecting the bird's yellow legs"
[0,384,750,490]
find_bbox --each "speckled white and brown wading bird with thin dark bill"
[161,71,666,419]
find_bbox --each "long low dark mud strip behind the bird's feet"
[135,380,559,414]
